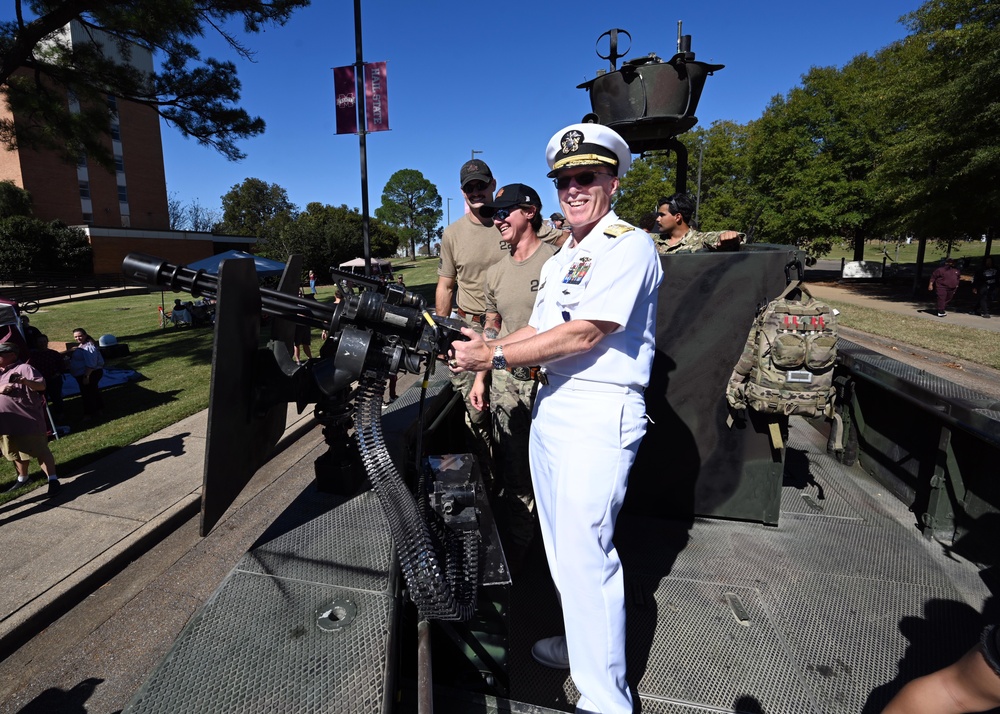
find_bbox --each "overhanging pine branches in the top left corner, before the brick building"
[0,0,309,165]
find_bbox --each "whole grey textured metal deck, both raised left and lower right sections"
[119,419,995,714]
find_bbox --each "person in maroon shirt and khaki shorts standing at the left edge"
[0,342,59,496]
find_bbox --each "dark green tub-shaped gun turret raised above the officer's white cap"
[577,22,725,191]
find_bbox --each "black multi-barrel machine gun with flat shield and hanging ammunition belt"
[122,253,480,620]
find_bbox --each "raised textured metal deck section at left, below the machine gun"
[125,489,397,714]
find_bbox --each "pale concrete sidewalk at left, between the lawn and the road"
[0,405,316,659]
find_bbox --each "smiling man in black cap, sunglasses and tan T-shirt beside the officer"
[470,183,557,574]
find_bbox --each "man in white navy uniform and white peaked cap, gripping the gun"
[453,124,663,714]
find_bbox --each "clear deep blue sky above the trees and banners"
[152,0,919,220]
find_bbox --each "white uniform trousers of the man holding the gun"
[529,380,646,714]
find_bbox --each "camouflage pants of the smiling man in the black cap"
[490,370,536,546]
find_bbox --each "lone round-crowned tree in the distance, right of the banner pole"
[375,169,442,258]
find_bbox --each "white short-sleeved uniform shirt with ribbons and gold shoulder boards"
[528,211,663,387]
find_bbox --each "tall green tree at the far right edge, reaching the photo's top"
[877,0,1000,246]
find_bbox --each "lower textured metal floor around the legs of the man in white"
[511,419,992,714]
